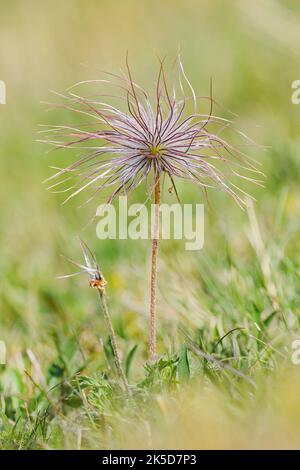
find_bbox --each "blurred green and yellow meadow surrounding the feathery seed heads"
[0,0,300,448]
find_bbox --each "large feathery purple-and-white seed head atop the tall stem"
[42,54,261,204]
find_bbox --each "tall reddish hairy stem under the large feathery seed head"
[150,173,160,360]
